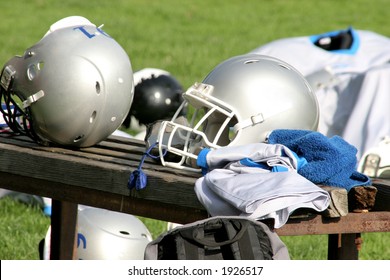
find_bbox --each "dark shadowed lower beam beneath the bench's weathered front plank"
[0,172,207,223]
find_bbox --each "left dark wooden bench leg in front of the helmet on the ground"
[50,200,77,260]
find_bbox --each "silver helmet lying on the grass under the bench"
[41,205,152,260]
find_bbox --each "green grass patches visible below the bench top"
[0,198,390,260]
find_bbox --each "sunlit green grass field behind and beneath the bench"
[0,0,390,259]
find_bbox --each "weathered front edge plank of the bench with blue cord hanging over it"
[0,138,206,208]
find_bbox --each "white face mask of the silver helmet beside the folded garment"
[146,83,234,172]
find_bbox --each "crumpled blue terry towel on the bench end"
[268,129,371,191]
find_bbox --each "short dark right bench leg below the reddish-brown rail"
[328,233,361,260]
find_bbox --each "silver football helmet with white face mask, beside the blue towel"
[157,54,319,170]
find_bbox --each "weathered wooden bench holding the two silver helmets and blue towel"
[0,133,390,259]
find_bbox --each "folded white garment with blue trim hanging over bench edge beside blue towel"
[195,143,329,228]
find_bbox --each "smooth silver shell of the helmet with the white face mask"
[203,54,319,145]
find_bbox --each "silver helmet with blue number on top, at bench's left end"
[0,17,134,147]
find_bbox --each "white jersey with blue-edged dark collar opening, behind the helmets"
[252,28,390,158]
